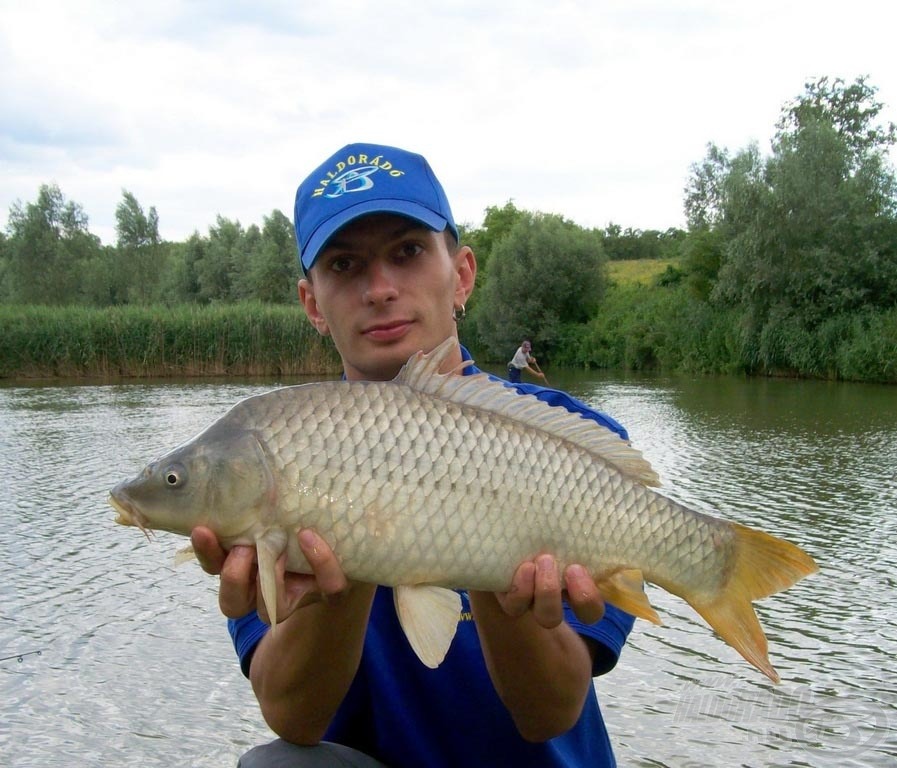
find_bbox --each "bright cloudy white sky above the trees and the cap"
[0,0,897,244]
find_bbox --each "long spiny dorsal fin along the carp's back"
[395,336,660,485]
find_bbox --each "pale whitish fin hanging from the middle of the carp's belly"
[393,586,461,669]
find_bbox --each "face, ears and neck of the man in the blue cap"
[299,214,476,380]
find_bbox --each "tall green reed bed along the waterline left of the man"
[0,302,340,379]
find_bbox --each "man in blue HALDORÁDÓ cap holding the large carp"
[192,144,633,768]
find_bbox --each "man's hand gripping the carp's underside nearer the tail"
[496,555,604,629]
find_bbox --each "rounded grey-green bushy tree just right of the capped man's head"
[476,214,606,359]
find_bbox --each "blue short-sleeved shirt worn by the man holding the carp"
[228,347,634,768]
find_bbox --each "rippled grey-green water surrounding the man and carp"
[0,372,897,768]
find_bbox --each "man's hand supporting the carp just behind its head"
[190,527,348,622]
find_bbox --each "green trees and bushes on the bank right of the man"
[458,78,897,382]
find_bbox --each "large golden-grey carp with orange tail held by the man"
[110,338,816,681]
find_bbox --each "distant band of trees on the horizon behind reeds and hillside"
[0,185,685,307]
